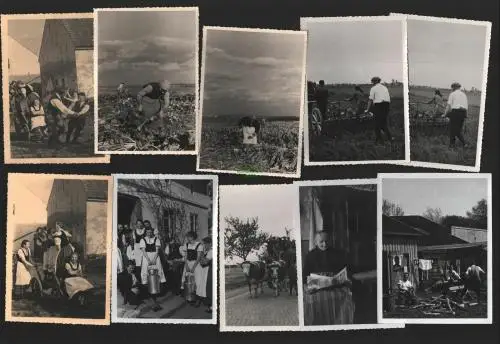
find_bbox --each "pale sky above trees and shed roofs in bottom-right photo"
[382,178,488,216]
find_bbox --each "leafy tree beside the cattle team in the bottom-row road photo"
[224,217,268,260]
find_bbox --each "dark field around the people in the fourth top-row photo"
[309,85,405,162]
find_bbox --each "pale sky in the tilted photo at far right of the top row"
[408,19,486,89]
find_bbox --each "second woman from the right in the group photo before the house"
[181,232,206,307]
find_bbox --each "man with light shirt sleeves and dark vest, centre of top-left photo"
[45,86,77,147]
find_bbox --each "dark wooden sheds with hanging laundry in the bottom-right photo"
[382,215,486,292]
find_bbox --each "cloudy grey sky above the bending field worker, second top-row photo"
[97,10,198,86]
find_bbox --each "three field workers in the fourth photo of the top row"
[308,76,393,143]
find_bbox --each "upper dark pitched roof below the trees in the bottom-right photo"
[392,215,466,245]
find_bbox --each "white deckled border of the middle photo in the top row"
[196,25,307,178]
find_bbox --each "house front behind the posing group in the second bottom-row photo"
[118,179,213,242]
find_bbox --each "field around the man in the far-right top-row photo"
[409,87,481,166]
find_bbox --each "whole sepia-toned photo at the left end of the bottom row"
[5,173,112,325]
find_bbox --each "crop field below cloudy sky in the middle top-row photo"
[200,119,299,174]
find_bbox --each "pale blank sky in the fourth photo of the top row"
[306,20,403,84]
